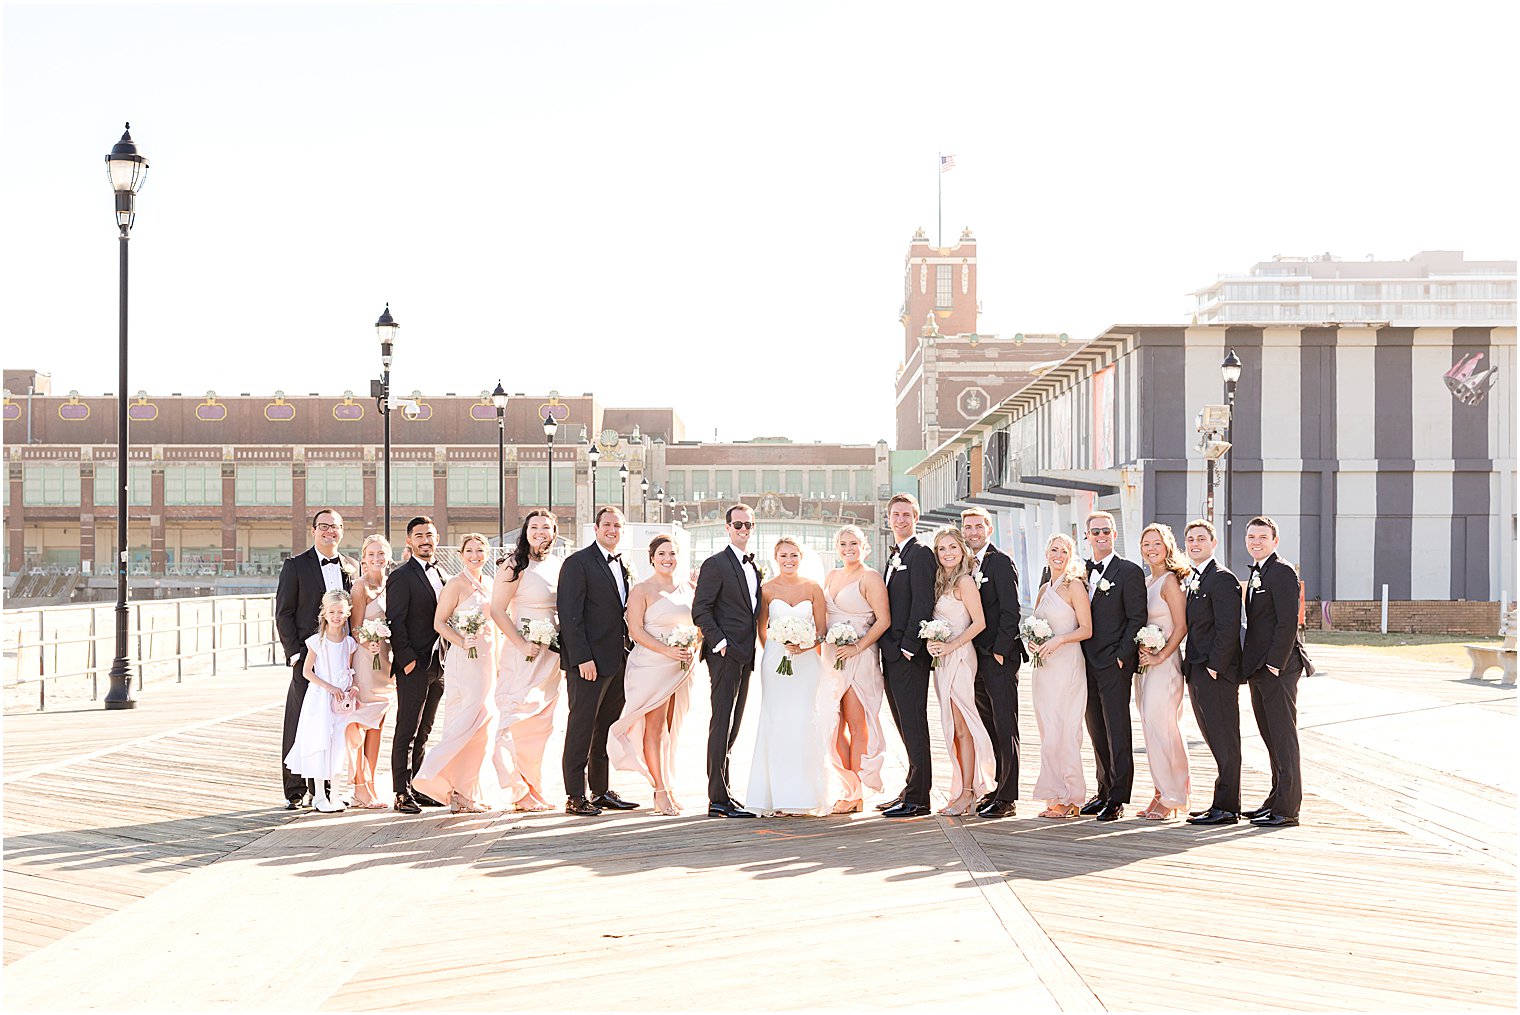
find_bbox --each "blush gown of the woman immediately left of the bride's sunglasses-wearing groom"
[606,585,705,789]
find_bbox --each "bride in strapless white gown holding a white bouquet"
[745,536,833,814]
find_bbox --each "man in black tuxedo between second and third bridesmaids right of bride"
[961,508,1028,817]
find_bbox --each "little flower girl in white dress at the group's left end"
[286,590,359,813]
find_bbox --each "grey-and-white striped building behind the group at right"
[912,324,1517,602]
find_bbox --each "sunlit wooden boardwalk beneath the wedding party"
[5,647,1517,1010]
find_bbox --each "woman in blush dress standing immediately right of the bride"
[822,526,892,814]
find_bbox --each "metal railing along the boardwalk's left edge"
[5,594,280,711]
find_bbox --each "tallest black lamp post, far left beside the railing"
[103,123,147,710]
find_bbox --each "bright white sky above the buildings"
[0,0,1520,442]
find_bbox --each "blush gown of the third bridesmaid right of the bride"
[1031,585,1087,807]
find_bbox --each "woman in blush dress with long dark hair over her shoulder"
[491,508,564,811]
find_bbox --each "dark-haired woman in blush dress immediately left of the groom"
[606,535,696,814]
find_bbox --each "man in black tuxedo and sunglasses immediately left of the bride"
[692,504,763,817]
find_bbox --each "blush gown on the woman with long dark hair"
[491,556,564,804]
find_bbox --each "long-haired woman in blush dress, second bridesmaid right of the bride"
[929,526,997,817]
